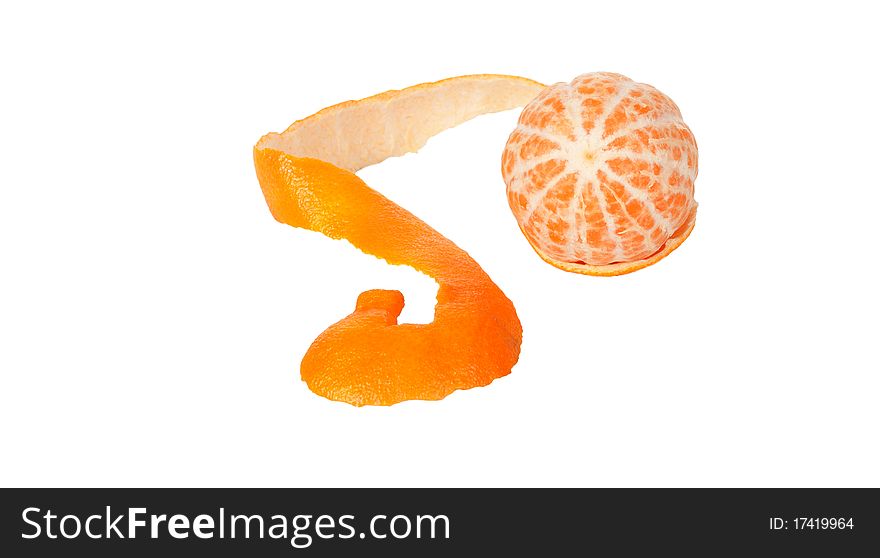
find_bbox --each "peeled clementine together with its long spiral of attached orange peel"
[254,73,697,405]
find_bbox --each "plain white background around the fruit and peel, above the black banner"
[0,0,880,486]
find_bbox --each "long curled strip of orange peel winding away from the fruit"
[254,75,544,406]
